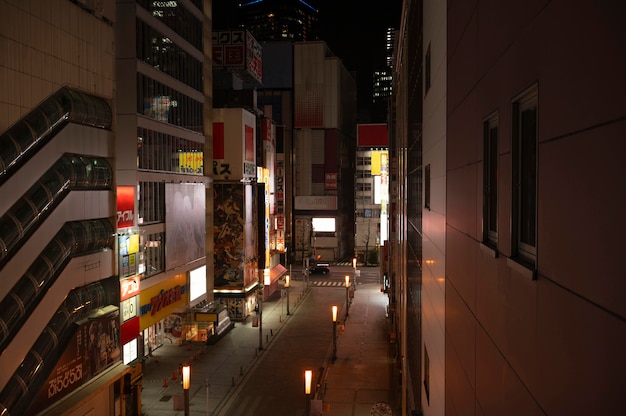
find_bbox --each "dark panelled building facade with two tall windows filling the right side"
[390,0,626,415]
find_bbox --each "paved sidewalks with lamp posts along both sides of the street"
[141,272,399,416]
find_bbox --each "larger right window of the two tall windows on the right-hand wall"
[512,86,538,265]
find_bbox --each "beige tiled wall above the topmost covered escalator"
[0,0,115,131]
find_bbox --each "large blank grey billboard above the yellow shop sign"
[165,183,206,270]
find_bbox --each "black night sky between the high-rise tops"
[311,0,402,113]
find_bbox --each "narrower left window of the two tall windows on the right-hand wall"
[483,113,498,248]
